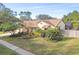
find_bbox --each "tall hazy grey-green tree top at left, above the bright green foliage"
[0,3,18,22]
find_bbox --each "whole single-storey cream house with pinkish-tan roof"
[22,19,65,30]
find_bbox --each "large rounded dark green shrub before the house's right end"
[46,28,63,41]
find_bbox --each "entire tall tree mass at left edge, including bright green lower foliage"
[0,3,19,31]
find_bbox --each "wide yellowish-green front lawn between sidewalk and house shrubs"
[3,37,79,55]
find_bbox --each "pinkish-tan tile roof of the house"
[23,19,61,27]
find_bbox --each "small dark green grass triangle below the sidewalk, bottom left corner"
[0,45,17,55]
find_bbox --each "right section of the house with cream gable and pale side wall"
[38,19,65,30]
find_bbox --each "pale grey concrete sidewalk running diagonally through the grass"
[0,40,34,55]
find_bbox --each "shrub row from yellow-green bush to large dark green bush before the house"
[34,28,63,41]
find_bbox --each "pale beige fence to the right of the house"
[63,30,79,38]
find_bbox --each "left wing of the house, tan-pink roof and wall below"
[22,20,38,32]
